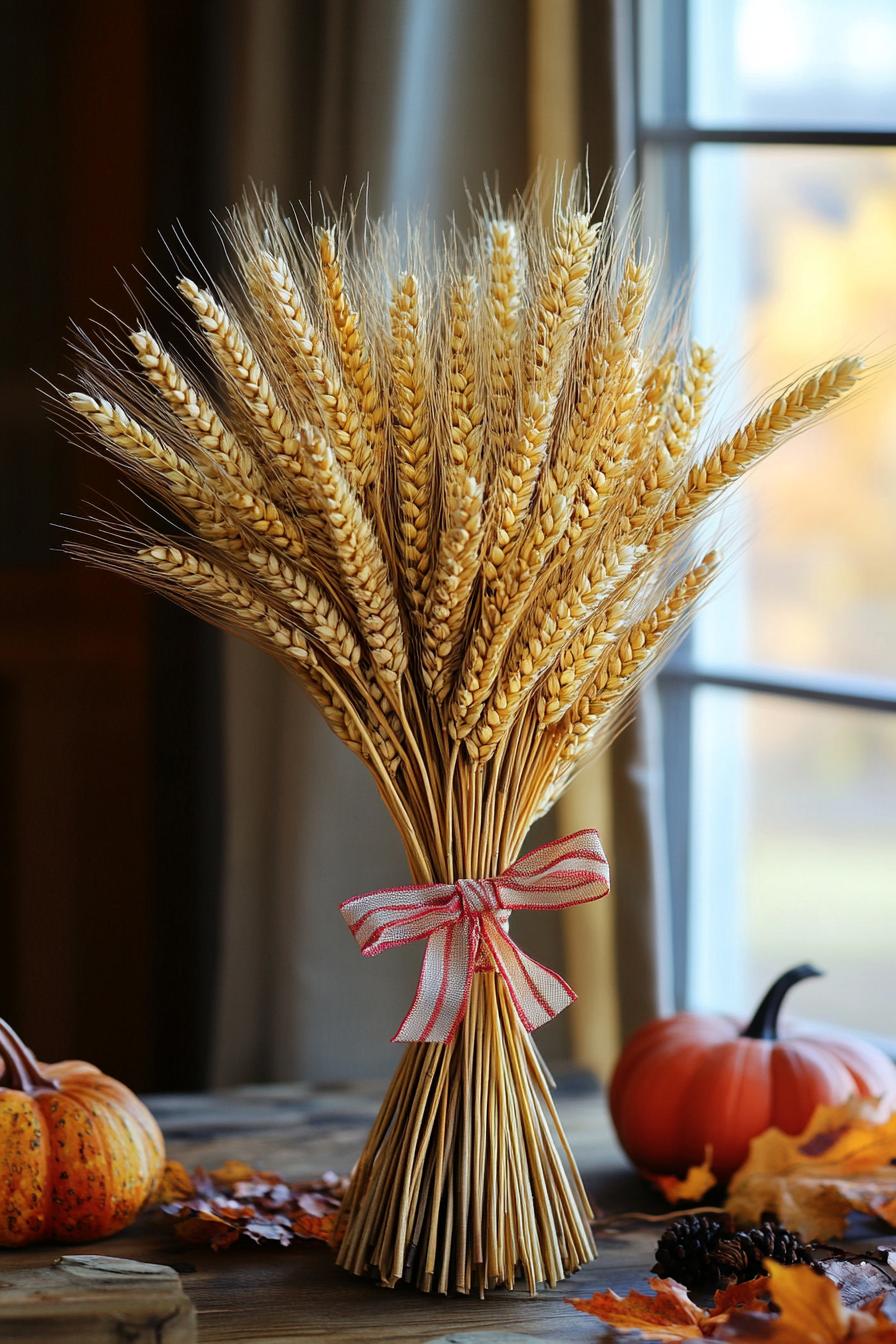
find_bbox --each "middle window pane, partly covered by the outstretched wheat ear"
[690,147,896,679]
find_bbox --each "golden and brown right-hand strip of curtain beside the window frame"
[529,0,672,1078]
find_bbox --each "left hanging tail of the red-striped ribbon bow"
[392,919,478,1043]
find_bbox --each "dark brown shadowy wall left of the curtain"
[0,0,252,1087]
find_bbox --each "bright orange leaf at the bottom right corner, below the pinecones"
[716,1262,896,1344]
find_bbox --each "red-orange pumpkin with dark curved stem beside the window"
[610,966,896,1179]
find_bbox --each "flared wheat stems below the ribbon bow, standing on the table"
[334,970,594,1296]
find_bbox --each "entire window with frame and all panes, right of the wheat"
[631,0,896,1038]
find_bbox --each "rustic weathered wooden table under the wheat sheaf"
[1,1078,800,1344]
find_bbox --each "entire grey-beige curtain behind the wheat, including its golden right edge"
[212,0,664,1083]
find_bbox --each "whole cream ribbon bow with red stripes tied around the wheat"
[340,831,610,1042]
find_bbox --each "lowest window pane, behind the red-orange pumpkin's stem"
[689,687,896,1038]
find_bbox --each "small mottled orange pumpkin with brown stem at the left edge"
[0,1020,165,1246]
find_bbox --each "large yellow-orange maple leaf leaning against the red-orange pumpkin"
[725,1097,896,1241]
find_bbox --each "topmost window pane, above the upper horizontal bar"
[693,0,896,129]
